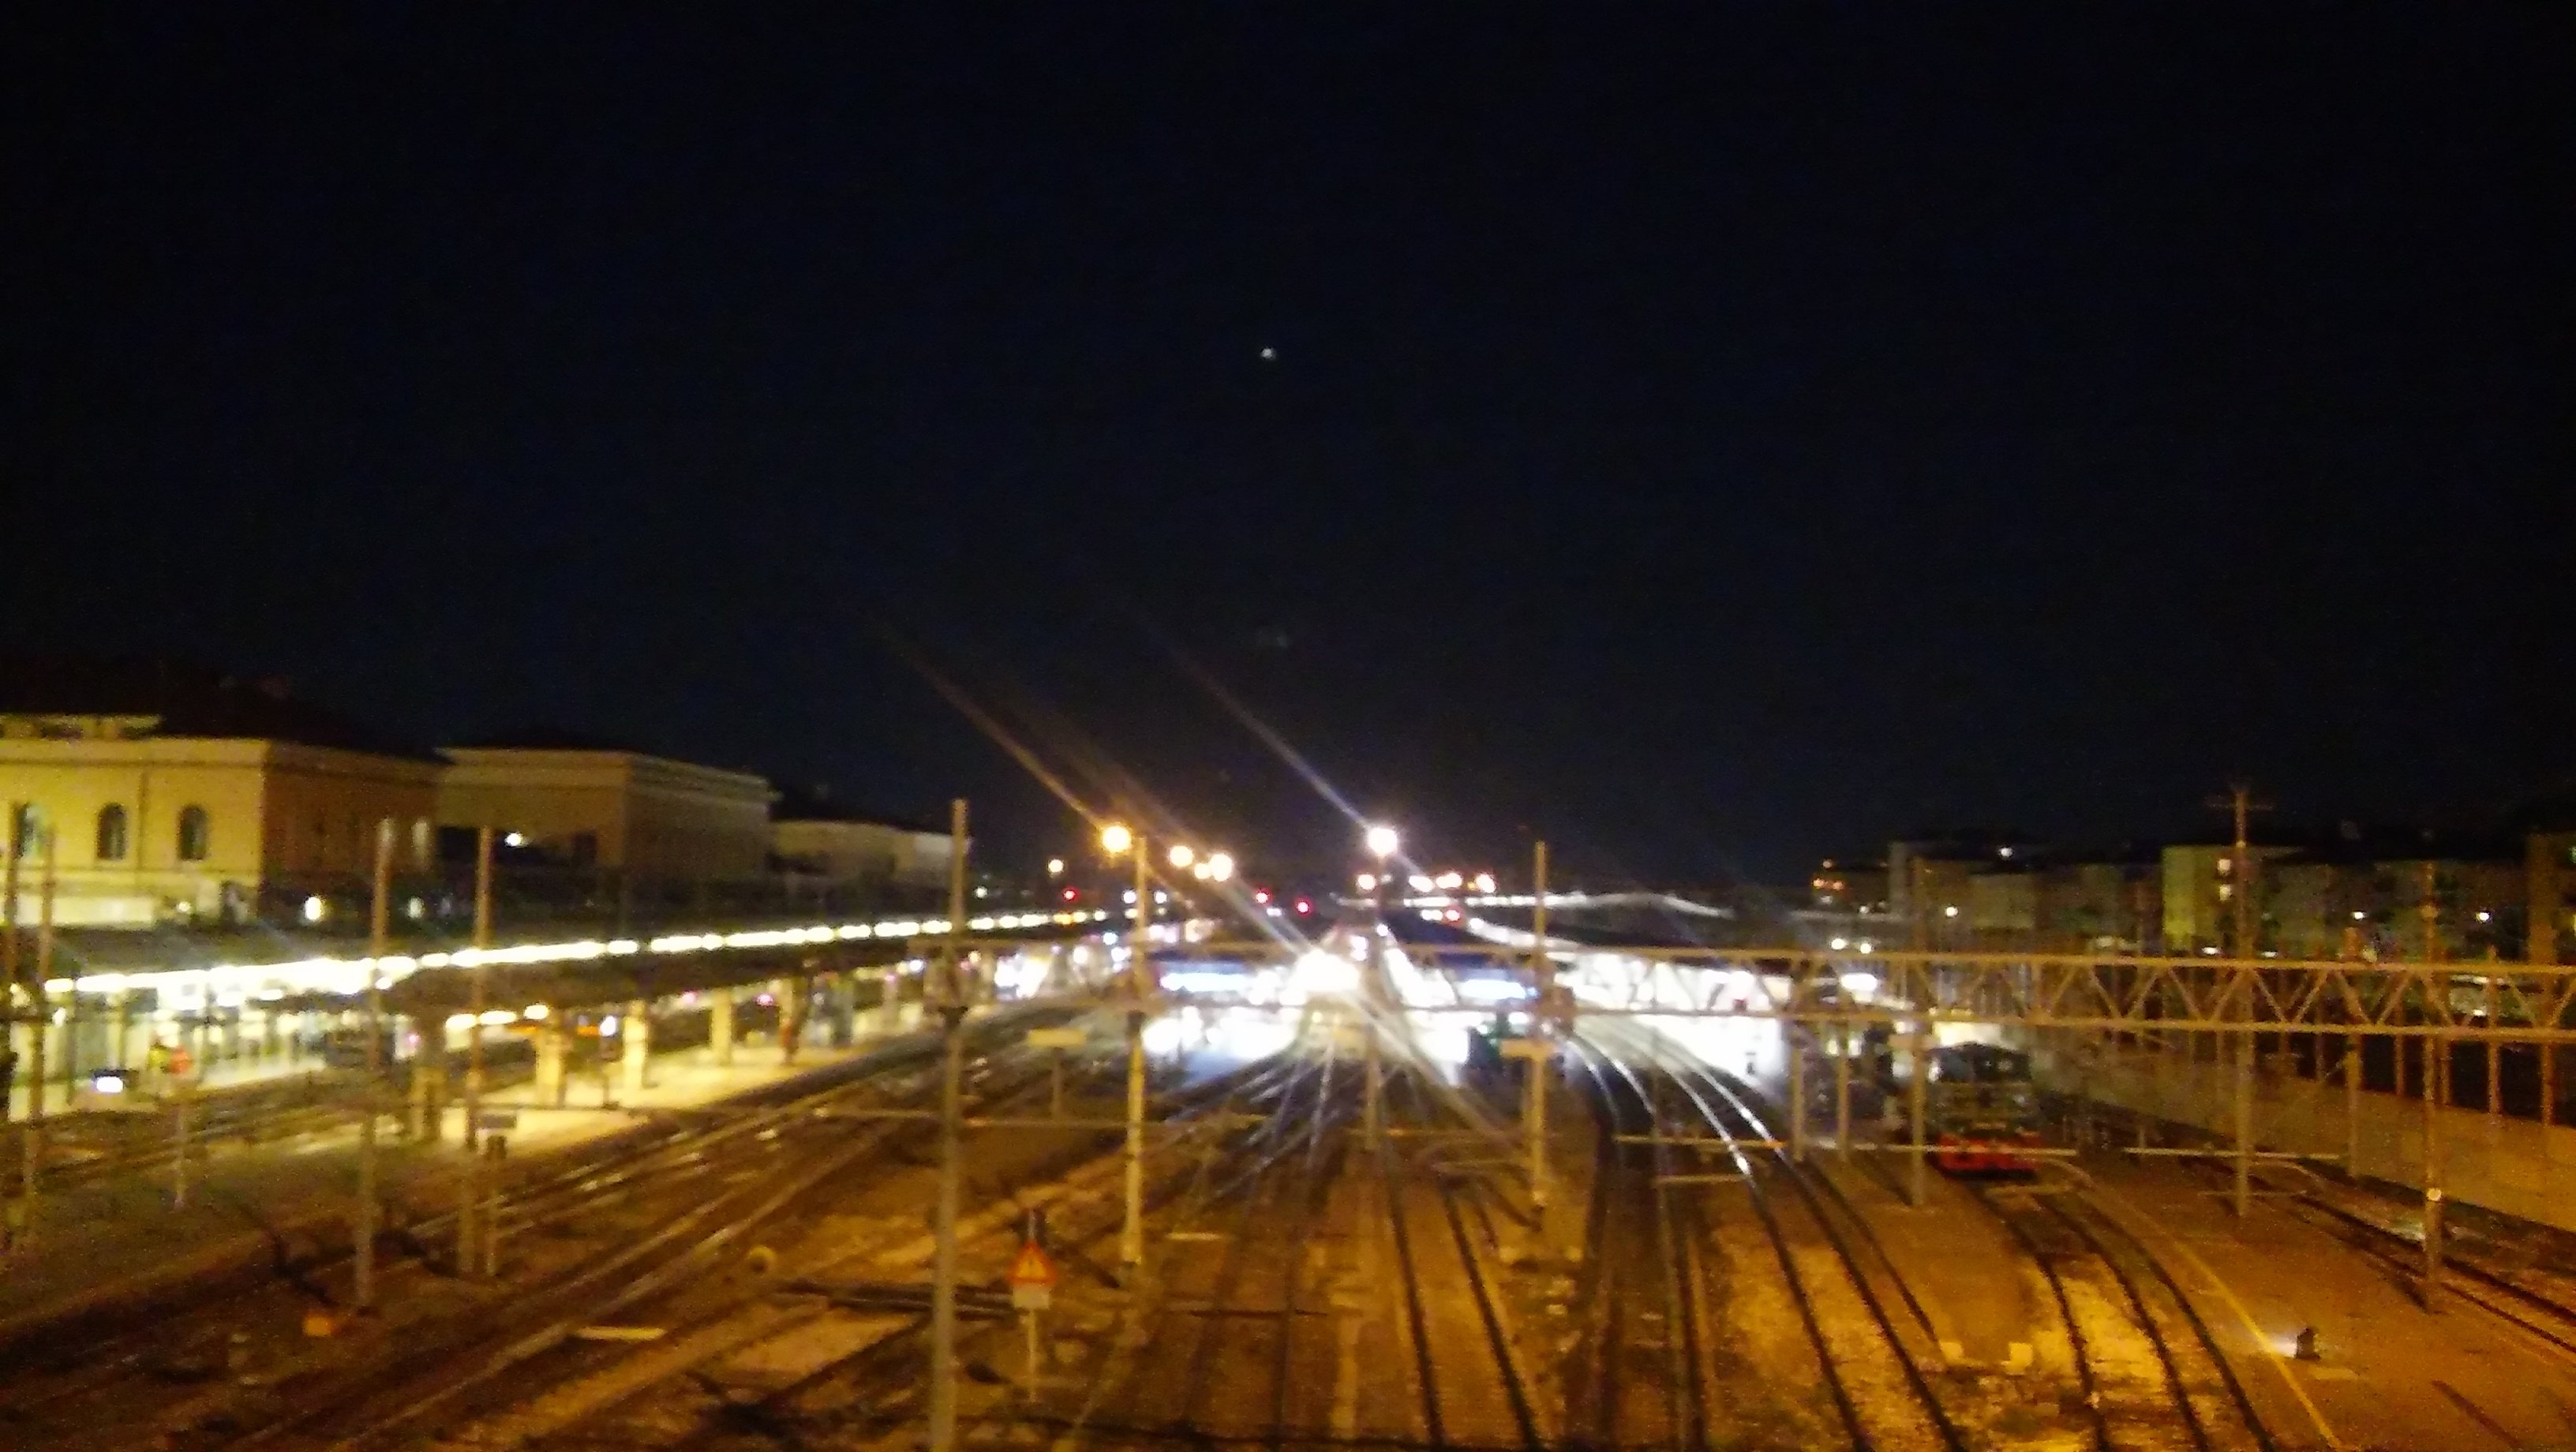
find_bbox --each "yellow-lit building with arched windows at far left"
[0,661,440,926]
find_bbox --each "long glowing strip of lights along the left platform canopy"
[43,909,1110,1009]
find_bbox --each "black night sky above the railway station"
[0,6,2576,878]
